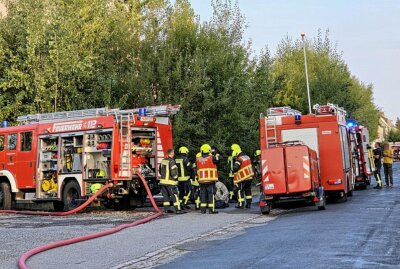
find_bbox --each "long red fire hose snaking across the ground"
[0,173,162,269]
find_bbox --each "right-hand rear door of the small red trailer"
[285,146,311,193]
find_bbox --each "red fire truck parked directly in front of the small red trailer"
[260,104,354,204]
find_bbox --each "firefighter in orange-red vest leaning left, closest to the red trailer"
[231,144,254,208]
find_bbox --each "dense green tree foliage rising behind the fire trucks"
[0,0,378,153]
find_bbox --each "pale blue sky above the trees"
[190,0,400,120]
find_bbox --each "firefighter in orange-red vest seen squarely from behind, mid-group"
[196,144,220,214]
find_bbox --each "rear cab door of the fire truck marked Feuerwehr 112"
[16,131,36,188]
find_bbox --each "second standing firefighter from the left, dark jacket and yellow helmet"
[175,147,192,209]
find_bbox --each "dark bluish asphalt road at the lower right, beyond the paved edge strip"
[158,163,400,269]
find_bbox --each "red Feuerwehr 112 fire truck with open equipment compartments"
[0,105,180,210]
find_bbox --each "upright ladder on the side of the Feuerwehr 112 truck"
[119,113,133,178]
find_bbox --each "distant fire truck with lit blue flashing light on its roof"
[347,123,375,188]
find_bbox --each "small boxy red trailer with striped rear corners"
[260,141,326,214]
